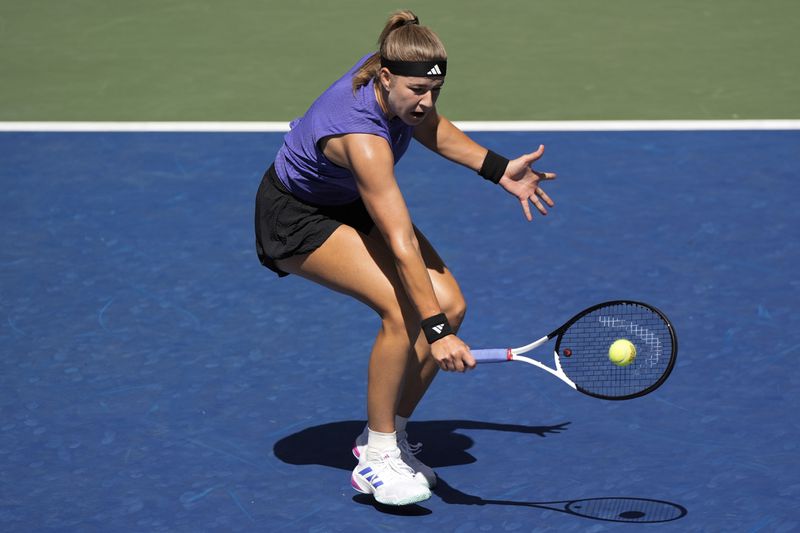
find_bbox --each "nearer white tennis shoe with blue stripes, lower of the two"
[350,448,431,505]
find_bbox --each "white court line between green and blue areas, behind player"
[0,119,800,132]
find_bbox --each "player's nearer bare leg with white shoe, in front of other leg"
[278,225,430,505]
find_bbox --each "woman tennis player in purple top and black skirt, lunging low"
[255,11,555,505]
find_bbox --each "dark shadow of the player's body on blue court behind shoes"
[273,420,569,470]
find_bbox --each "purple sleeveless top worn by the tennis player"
[275,54,414,205]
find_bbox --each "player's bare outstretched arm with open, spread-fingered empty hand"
[414,109,556,220]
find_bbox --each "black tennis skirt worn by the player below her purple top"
[256,165,375,277]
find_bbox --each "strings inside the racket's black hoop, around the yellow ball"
[559,303,673,398]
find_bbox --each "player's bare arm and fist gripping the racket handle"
[324,134,475,371]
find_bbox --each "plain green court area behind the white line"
[0,0,800,121]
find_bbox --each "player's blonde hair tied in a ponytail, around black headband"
[353,9,447,91]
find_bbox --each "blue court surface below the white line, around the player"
[0,128,800,533]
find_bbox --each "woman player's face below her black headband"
[381,74,444,126]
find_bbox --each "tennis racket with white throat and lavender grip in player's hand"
[472,300,678,400]
